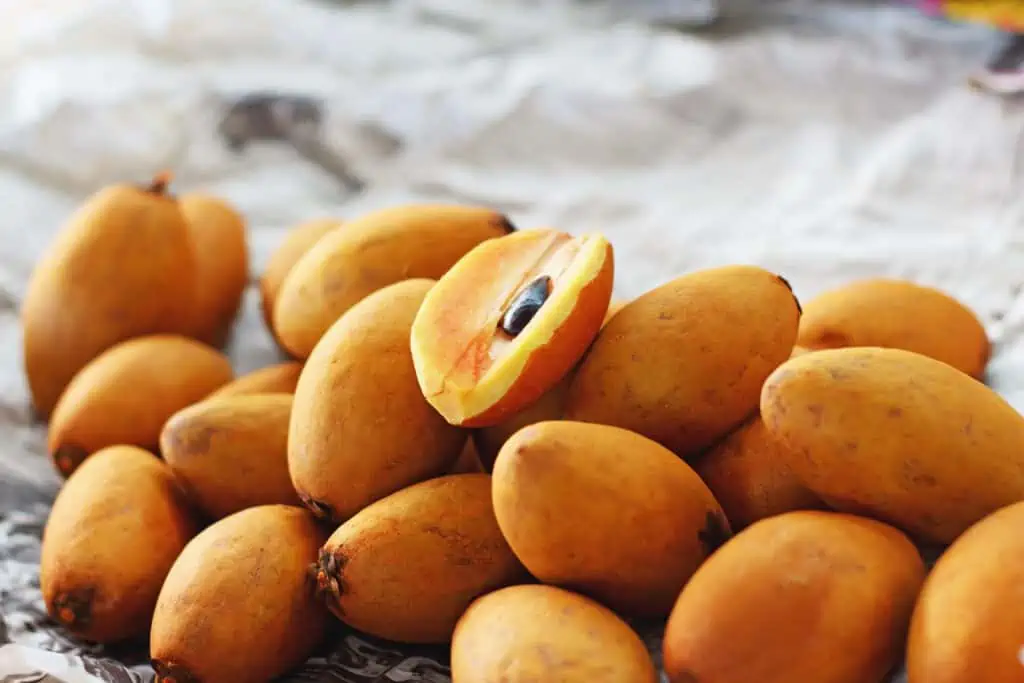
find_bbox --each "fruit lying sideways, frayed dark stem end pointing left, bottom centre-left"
[316,474,528,643]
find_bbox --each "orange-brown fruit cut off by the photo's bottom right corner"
[907,503,1024,683]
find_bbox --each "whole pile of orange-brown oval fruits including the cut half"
[23,174,1024,683]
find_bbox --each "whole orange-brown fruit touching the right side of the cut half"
[565,265,800,458]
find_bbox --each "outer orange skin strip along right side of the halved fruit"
[460,244,615,427]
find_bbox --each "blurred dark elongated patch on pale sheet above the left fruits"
[217,92,366,193]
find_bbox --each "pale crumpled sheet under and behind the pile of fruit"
[0,0,1024,683]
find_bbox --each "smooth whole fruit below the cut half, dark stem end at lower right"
[493,422,729,616]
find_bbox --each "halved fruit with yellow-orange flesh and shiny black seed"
[412,229,614,427]
